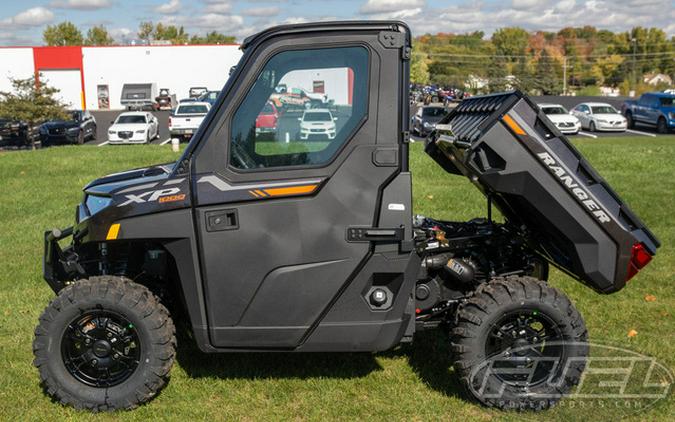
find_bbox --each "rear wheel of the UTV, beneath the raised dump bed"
[451,277,588,410]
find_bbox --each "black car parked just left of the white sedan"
[40,110,96,147]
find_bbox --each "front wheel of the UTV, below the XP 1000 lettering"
[33,276,176,411]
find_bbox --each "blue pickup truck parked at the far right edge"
[622,92,675,133]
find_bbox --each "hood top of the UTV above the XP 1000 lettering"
[83,162,176,196]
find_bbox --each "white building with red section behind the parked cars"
[0,45,242,110]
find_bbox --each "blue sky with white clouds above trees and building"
[0,0,675,45]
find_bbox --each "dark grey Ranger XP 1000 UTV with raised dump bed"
[33,22,659,410]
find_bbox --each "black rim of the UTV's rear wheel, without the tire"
[485,309,566,388]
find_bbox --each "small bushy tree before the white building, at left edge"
[0,76,67,148]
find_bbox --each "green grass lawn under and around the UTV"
[0,136,675,421]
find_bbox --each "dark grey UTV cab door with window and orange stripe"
[187,24,412,349]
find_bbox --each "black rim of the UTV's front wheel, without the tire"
[61,310,141,388]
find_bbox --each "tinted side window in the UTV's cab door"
[229,47,369,169]
